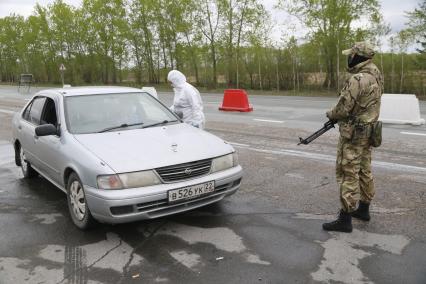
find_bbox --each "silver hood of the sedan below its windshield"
[74,123,234,173]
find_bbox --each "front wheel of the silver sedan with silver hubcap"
[67,173,95,230]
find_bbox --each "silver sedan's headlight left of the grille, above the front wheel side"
[98,171,161,189]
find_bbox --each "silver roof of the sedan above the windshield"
[37,86,144,97]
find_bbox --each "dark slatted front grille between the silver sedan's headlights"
[155,159,212,182]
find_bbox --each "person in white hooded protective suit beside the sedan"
[167,70,205,129]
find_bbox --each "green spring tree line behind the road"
[0,0,426,96]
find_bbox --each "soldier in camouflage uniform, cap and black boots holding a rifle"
[323,42,383,232]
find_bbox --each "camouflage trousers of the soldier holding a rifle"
[336,137,375,212]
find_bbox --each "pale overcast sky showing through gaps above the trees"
[0,0,421,49]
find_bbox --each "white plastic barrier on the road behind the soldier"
[379,94,425,125]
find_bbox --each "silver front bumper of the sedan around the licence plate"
[84,166,242,224]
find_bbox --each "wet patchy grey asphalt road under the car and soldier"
[0,87,426,283]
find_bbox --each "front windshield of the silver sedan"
[65,93,178,134]
